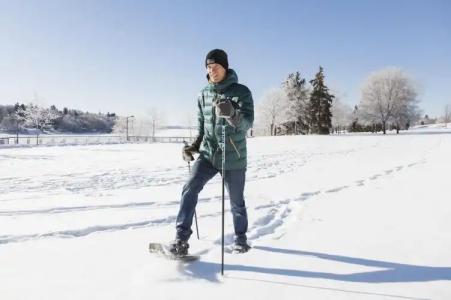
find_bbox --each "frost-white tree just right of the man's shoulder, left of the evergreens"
[255,88,291,135]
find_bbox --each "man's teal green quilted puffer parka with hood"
[194,69,254,170]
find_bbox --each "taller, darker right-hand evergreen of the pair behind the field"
[308,66,335,134]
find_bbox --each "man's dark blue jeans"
[176,158,248,243]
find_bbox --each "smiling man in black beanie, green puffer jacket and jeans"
[170,49,254,256]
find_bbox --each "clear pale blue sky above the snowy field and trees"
[0,0,451,124]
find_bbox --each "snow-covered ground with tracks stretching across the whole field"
[0,134,451,300]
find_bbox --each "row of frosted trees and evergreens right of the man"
[256,67,421,135]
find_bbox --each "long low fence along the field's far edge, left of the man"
[0,135,194,146]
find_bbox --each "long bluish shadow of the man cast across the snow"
[179,246,451,283]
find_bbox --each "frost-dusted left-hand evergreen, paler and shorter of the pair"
[282,72,310,134]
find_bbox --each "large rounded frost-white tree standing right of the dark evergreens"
[359,68,418,134]
